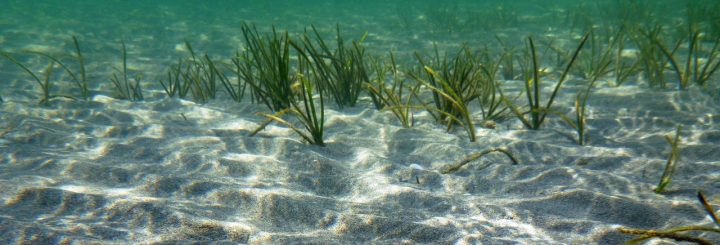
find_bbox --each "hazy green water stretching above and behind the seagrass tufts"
[0,0,720,89]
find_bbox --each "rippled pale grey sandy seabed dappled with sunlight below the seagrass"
[0,80,720,244]
